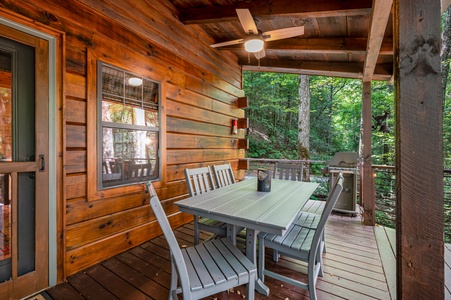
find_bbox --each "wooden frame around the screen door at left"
[0,15,64,286]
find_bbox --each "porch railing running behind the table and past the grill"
[246,158,451,243]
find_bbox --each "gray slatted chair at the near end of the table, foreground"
[147,182,257,300]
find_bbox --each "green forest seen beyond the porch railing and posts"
[243,8,451,237]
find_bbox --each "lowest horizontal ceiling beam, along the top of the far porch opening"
[239,58,393,81]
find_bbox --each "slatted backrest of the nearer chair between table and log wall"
[185,167,215,197]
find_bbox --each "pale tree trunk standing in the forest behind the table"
[297,75,310,181]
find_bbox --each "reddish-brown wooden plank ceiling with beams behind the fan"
[171,0,393,81]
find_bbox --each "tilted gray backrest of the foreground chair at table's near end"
[146,181,190,287]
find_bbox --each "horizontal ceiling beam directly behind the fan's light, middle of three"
[218,38,393,55]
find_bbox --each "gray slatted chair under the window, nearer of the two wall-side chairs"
[185,167,227,245]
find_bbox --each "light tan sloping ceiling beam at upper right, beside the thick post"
[363,0,393,82]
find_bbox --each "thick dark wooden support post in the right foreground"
[393,0,445,299]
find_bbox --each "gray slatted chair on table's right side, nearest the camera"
[258,173,343,300]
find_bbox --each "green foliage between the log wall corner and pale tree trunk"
[243,72,298,159]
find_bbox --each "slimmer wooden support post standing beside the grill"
[360,81,376,226]
